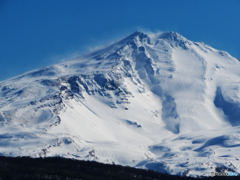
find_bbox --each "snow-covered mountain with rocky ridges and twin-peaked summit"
[0,32,240,176]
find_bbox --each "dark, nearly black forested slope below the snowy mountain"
[0,157,239,180]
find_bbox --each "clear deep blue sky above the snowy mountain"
[0,0,240,81]
